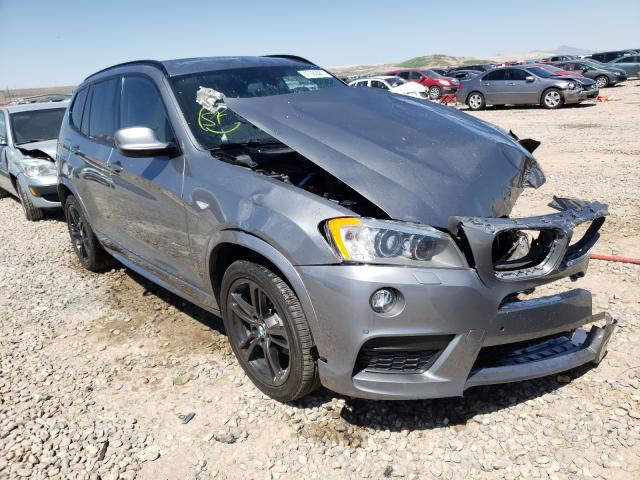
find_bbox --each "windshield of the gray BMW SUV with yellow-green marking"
[171,65,346,149]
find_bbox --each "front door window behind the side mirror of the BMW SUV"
[120,77,174,142]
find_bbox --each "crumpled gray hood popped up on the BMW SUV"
[225,88,544,228]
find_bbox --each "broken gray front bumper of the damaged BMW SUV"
[297,197,616,399]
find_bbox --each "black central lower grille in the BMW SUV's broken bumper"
[473,332,582,369]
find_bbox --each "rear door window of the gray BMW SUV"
[89,78,120,143]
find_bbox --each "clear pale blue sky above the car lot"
[0,0,640,89]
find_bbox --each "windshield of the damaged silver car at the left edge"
[10,108,66,145]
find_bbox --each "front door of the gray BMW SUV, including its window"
[108,74,194,282]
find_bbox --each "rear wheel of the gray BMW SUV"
[64,195,113,272]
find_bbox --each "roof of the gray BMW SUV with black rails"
[86,55,315,80]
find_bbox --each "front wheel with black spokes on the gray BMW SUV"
[220,260,319,402]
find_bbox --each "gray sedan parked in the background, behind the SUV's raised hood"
[456,66,587,110]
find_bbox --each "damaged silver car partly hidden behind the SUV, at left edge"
[0,100,69,221]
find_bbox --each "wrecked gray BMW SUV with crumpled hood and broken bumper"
[57,56,616,401]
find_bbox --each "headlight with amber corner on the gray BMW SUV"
[325,217,467,268]
